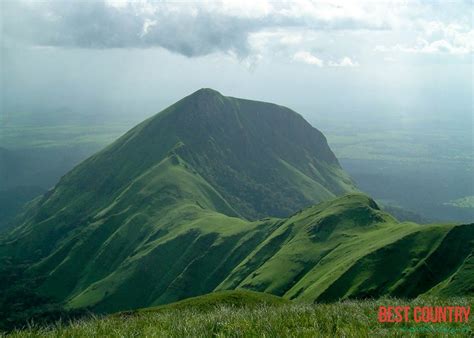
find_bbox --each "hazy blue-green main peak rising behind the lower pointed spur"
[34,88,354,219]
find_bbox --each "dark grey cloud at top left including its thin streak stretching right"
[3,1,386,57]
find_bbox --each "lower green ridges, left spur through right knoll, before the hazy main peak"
[3,154,474,312]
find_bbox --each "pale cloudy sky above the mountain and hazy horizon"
[0,0,474,130]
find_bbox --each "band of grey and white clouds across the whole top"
[1,0,474,62]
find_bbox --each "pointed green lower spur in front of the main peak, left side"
[4,155,271,310]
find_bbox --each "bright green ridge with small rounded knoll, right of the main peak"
[217,194,474,301]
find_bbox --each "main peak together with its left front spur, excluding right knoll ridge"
[0,89,354,311]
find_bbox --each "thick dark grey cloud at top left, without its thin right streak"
[1,1,256,56]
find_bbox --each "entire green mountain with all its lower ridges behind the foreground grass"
[0,89,474,320]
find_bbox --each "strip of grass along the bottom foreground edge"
[5,296,474,337]
